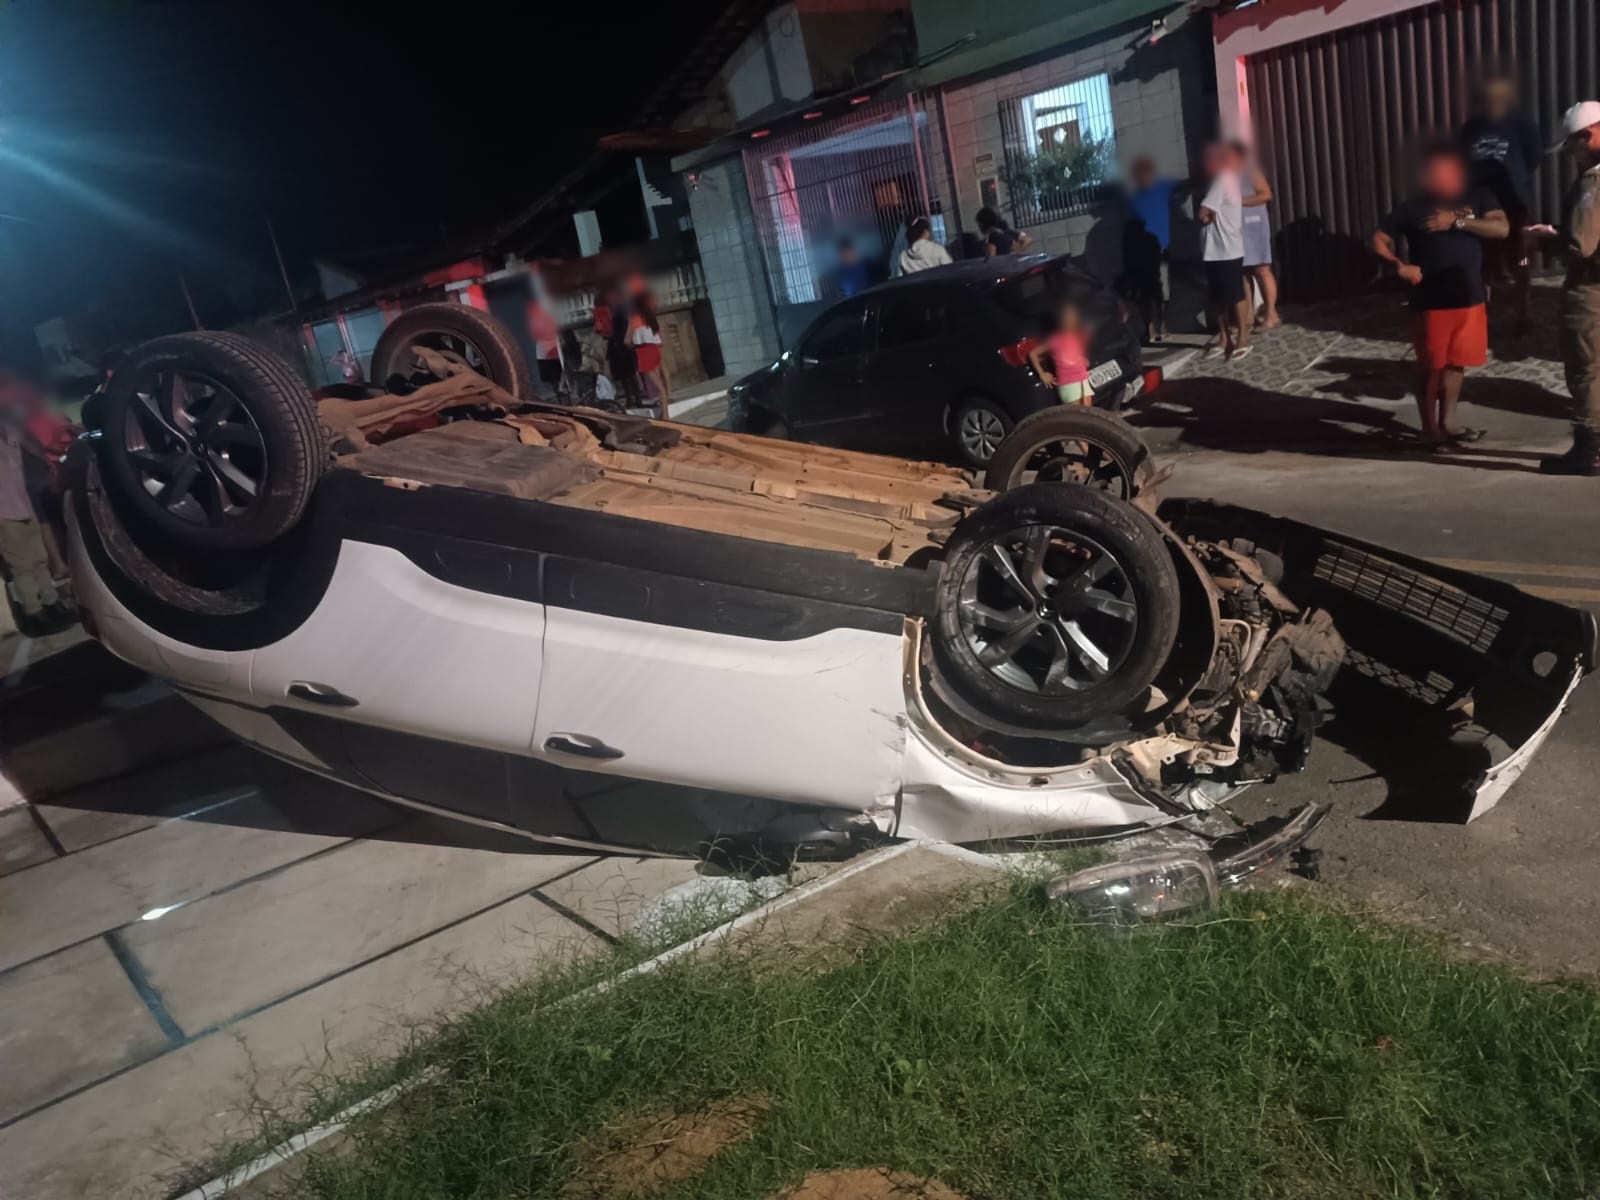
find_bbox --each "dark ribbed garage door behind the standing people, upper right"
[1245,0,1600,299]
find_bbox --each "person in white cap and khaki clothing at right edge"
[1538,101,1600,475]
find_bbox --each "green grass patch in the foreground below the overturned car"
[272,886,1600,1200]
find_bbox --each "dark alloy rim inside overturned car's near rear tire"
[123,370,267,526]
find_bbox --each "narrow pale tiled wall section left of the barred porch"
[690,158,778,374]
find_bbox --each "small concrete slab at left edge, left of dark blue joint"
[0,939,166,1122]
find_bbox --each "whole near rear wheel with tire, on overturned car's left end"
[98,331,328,550]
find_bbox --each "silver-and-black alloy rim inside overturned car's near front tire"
[957,525,1139,696]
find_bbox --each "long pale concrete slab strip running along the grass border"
[0,896,594,1200]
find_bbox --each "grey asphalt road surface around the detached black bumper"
[1163,448,1600,976]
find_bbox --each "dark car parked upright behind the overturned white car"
[728,254,1142,467]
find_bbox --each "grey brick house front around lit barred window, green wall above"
[915,0,1216,280]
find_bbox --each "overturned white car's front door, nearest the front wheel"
[534,563,906,810]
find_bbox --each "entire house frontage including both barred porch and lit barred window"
[674,0,1216,374]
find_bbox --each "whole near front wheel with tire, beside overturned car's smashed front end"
[931,485,1179,731]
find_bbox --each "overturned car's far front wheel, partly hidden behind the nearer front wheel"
[984,406,1155,501]
